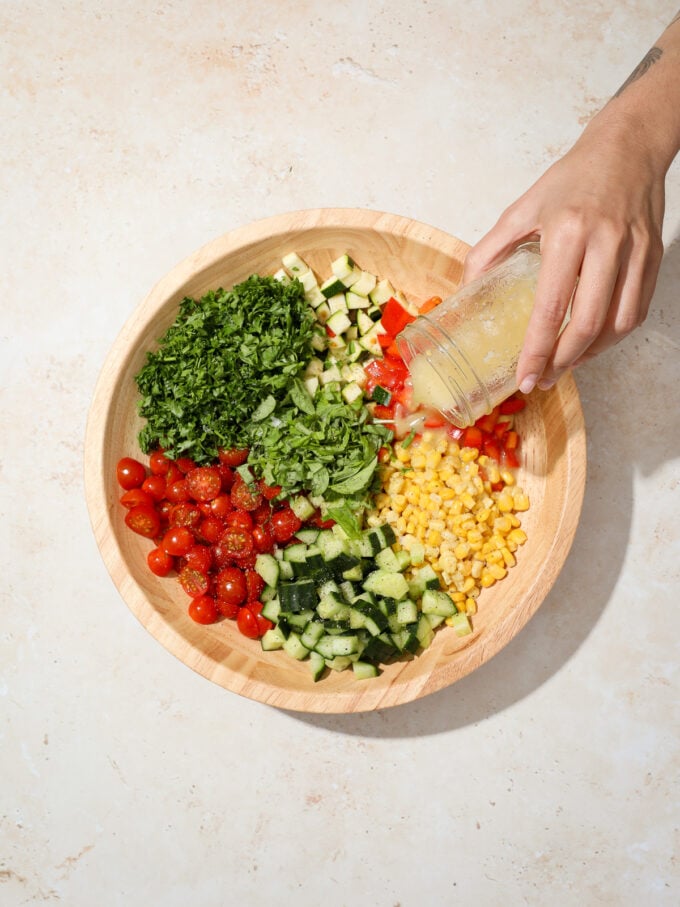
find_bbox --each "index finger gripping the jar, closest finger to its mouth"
[517,236,585,394]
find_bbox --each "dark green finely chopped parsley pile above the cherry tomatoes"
[136,275,315,463]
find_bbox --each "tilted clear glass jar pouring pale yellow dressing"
[397,242,541,428]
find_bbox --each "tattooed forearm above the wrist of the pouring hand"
[583,12,680,173]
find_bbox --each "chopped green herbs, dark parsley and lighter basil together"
[136,275,392,507]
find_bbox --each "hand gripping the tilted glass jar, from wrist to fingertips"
[463,118,665,393]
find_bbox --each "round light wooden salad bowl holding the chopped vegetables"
[85,209,585,713]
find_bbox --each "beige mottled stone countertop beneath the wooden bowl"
[0,0,680,907]
